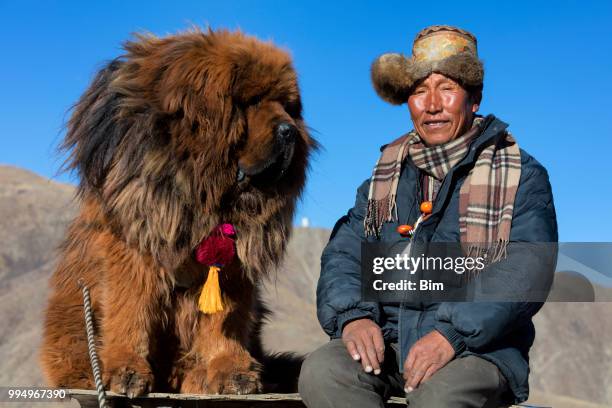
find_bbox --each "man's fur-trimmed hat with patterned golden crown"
[371,25,484,105]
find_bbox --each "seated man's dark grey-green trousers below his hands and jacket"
[299,339,508,408]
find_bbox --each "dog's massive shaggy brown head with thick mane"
[64,30,316,270]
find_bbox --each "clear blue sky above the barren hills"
[0,0,612,241]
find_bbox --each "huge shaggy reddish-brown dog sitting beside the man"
[41,30,316,397]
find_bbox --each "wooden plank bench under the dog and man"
[66,389,537,408]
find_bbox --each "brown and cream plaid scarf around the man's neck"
[364,117,521,263]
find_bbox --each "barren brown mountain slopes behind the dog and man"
[0,166,612,407]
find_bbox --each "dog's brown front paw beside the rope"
[104,358,153,398]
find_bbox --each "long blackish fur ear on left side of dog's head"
[60,60,125,189]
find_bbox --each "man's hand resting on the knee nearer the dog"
[342,319,385,375]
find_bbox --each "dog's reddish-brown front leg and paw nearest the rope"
[100,249,166,398]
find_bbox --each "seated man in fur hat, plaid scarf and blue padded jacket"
[299,26,557,408]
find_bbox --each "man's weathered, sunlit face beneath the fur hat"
[408,73,479,146]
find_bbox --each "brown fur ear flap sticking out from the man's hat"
[371,54,414,105]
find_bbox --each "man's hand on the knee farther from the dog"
[404,330,455,392]
